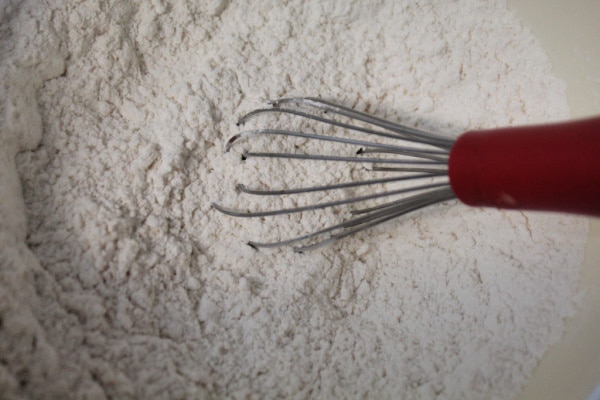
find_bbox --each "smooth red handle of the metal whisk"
[448,117,600,216]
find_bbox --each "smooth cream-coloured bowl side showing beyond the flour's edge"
[508,0,600,400]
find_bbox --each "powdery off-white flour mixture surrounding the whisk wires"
[0,0,588,399]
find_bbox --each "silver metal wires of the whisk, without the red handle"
[212,97,455,252]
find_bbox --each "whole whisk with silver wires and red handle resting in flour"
[213,97,600,252]
